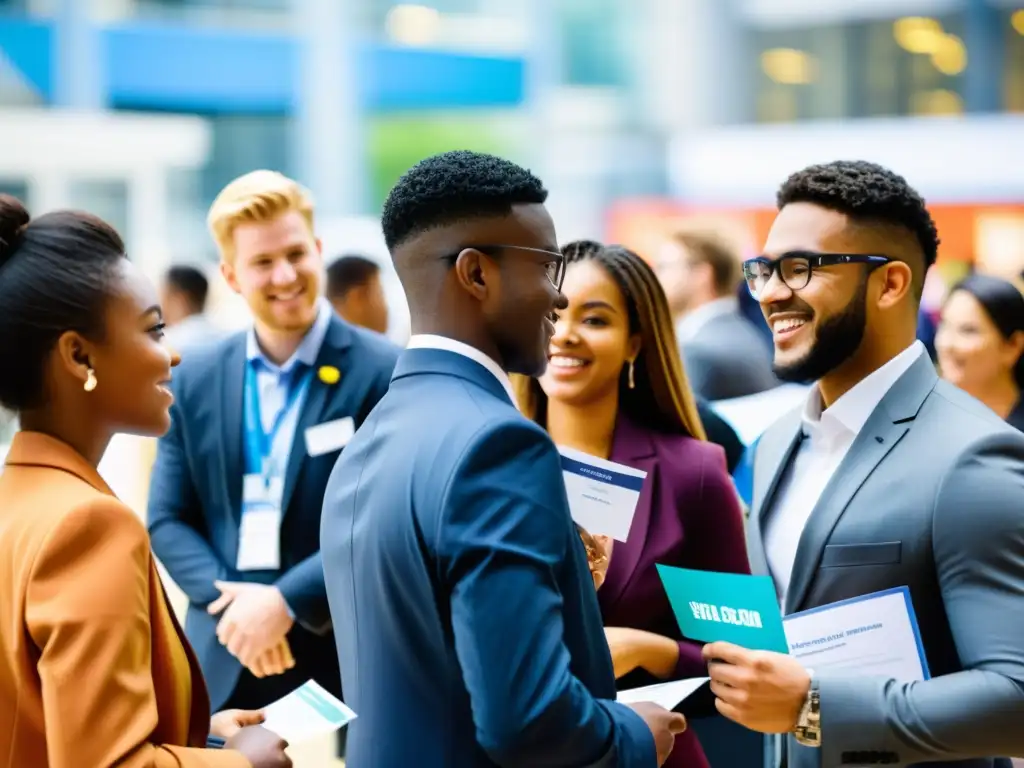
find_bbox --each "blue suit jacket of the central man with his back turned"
[321,349,656,768]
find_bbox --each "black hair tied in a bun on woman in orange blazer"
[0,195,126,412]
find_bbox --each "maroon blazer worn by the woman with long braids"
[597,415,751,768]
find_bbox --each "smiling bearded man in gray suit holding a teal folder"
[705,163,1024,768]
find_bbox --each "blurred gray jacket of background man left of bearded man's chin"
[680,311,778,400]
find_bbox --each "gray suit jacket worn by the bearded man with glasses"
[748,355,1024,768]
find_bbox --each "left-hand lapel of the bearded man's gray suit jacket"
[746,409,803,574]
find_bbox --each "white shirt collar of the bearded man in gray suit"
[803,341,925,438]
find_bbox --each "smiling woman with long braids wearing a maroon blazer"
[515,242,750,768]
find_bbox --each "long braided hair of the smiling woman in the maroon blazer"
[513,240,707,440]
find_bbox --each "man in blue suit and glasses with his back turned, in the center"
[321,152,685,768]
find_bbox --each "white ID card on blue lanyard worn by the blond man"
[236,361,312,570]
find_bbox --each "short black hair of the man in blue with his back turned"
[381,150,548,251]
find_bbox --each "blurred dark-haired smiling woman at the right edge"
[935,274,1024,430]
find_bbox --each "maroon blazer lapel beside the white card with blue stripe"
[598,416,657,606]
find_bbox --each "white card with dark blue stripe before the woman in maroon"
[558,447,647,542]
